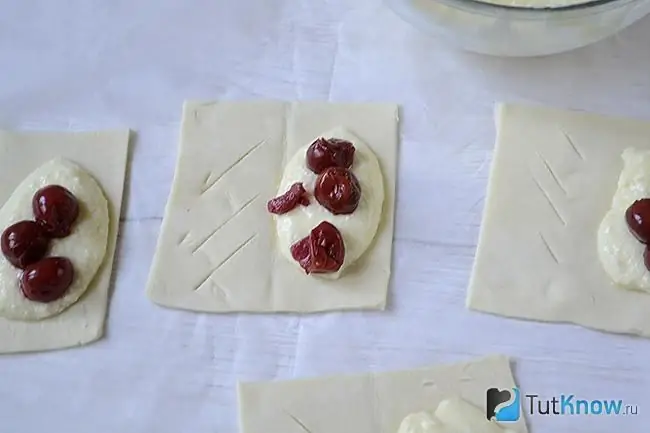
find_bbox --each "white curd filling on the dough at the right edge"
[598,148,650,291]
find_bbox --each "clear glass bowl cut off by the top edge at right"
[385,0,650,57]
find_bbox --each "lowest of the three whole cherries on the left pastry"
[20,257,74,303]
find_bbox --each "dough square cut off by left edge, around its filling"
[0,130,129,353]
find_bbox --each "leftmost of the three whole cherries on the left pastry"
[0,221,49,269]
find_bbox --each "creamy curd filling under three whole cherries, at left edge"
[0,158,109,320]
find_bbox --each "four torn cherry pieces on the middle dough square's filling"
[267,138,361,274]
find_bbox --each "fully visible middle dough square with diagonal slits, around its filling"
[147,101,398,312]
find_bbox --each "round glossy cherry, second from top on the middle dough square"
[314,167,361,215]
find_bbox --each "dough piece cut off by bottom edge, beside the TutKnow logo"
[238,355,527,433]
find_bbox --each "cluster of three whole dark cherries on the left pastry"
[0,185,79,303]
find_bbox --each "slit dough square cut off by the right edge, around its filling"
[467,104,650,337]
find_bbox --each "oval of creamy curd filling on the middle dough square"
[275,128,384,278]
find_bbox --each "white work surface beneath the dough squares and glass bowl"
[0,0,650,433]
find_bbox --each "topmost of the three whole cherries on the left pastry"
[32,185,79,238]
